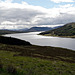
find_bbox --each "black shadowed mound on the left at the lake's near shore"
[0,36,31,45]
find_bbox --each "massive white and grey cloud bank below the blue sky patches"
[0,0,75,29]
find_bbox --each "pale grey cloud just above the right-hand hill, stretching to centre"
[37,13,75,25]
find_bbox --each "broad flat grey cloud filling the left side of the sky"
[0,8,43,22]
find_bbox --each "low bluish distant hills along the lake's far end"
[0,26,60,35]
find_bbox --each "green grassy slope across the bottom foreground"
[0,50,75,75]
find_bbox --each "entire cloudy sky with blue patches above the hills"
[0,0,75,29]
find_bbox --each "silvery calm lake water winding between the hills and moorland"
[5,32,75,50]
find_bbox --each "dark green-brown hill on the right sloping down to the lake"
[40,22,75,37]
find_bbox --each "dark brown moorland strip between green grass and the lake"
[0,44,75,63]
